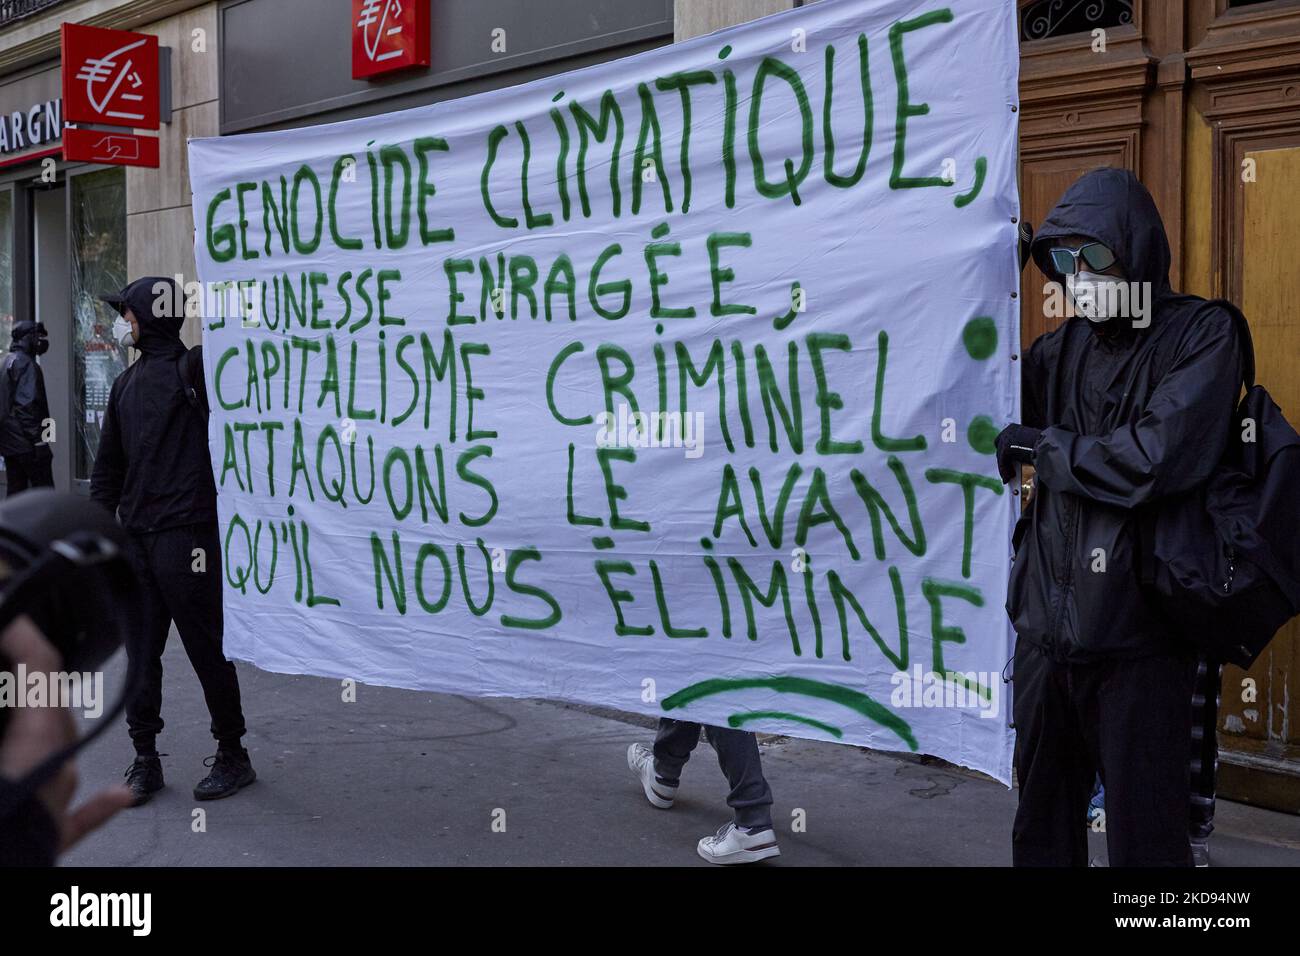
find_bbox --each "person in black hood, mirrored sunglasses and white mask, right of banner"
[997,169,1242,866]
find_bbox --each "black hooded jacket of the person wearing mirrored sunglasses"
[1008,169,1242,662]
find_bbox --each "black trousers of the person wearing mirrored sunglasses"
[1011,640,1196,866]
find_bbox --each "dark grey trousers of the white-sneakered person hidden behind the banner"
[654,717,772,830]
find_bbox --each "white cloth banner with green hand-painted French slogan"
[190,0,1019,780]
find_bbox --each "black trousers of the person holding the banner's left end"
[126,523,244,754]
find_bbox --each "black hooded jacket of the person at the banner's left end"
[90,277,217,533]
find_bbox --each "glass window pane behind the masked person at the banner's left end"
[69,169,126,480]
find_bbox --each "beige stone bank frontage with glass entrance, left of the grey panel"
[0,0,217,490]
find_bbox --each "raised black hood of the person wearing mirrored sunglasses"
[1032,169,1170,299]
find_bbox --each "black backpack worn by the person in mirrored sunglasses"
[1140,299,1300,667]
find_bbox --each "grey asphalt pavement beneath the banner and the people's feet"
[64,632,1300,866]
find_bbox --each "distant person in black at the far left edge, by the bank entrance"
[0,320,55,494]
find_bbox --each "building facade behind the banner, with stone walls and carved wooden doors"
[0,0,1300,813]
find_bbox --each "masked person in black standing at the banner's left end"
[91,277,256,804]
